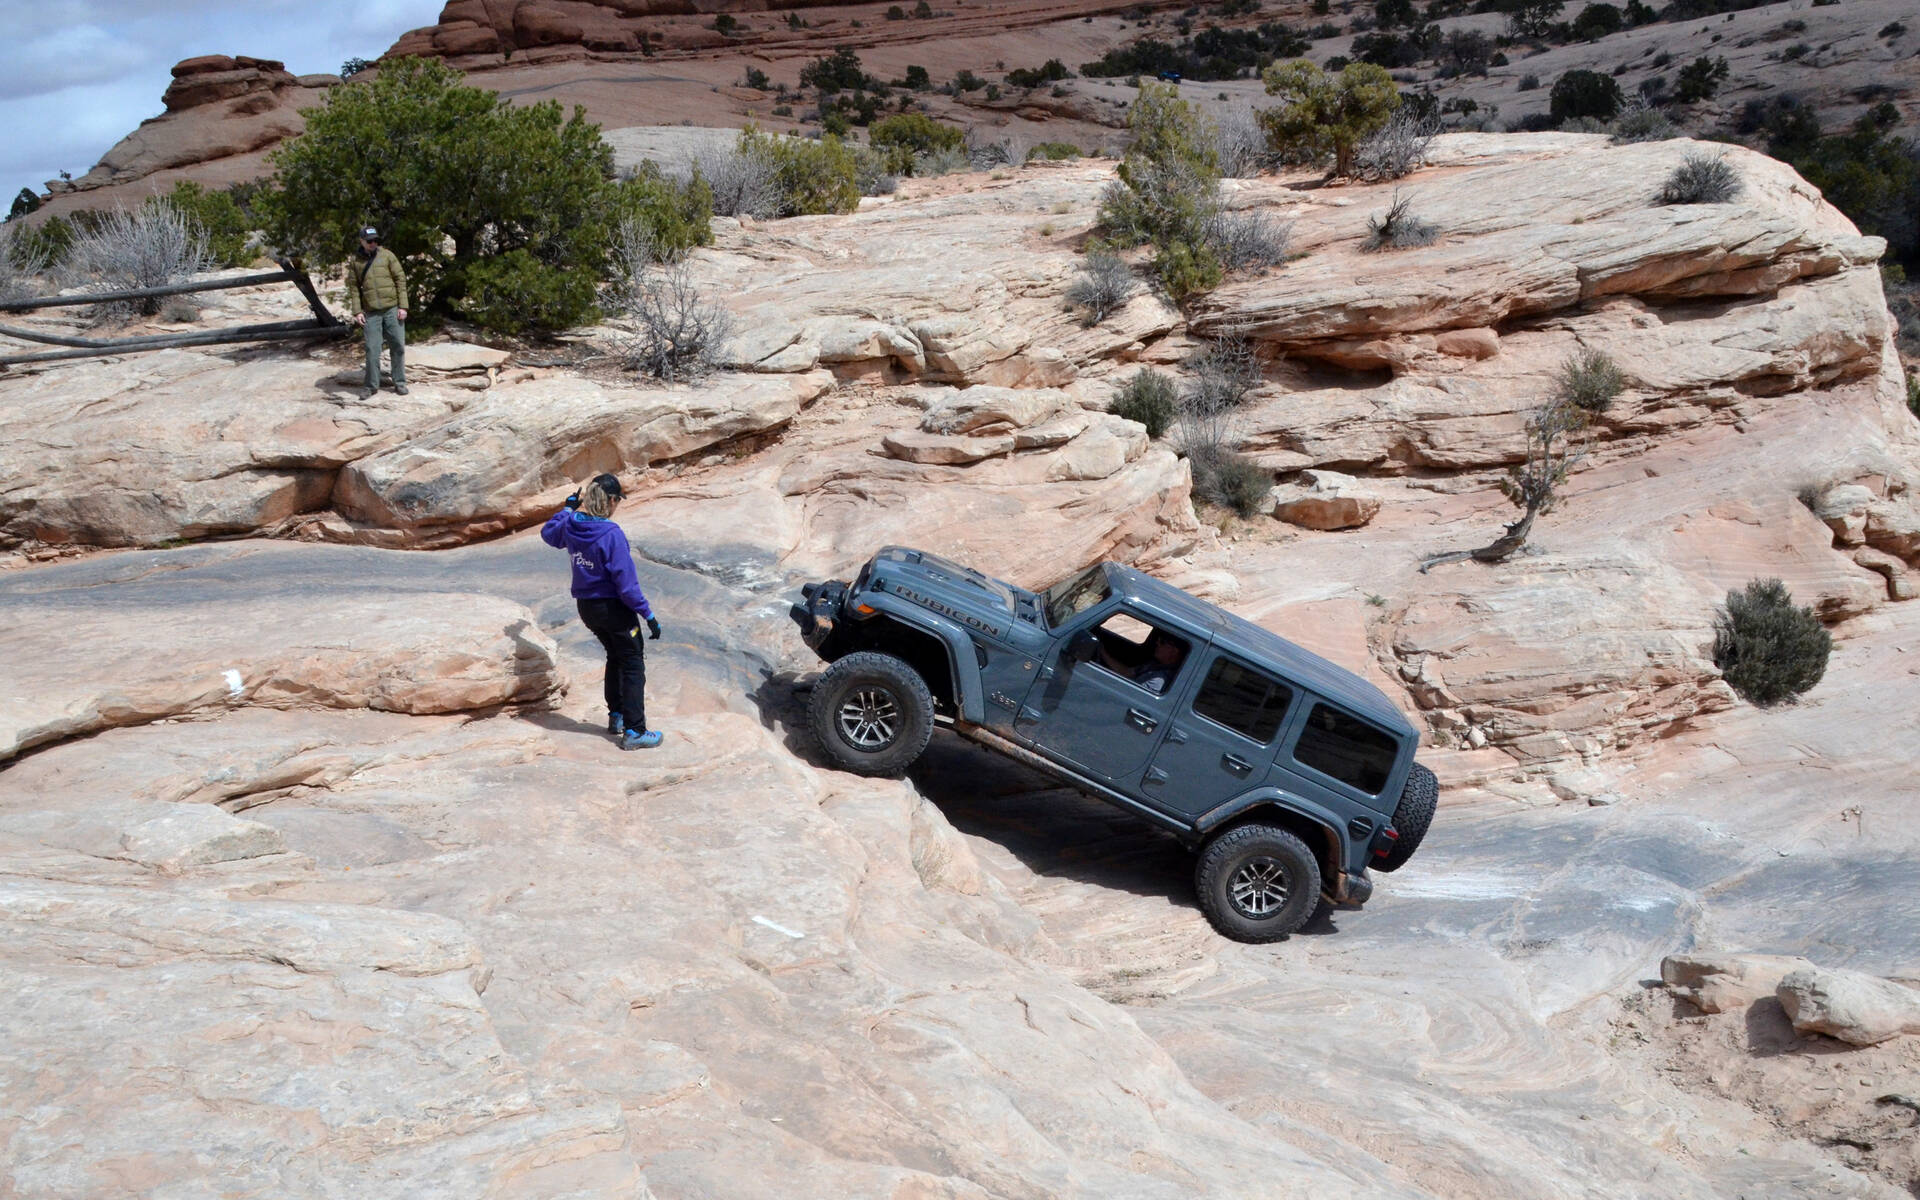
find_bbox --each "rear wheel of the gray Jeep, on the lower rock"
[1194,826,1321,943]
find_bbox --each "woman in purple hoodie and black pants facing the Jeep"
[540,474,660,751]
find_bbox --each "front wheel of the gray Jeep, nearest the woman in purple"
[806,651,933,776]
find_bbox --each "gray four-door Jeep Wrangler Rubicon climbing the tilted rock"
[791,545,1438,943]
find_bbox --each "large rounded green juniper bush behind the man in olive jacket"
[259,58,614,328]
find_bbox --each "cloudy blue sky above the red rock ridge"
[0,0,442,202]
